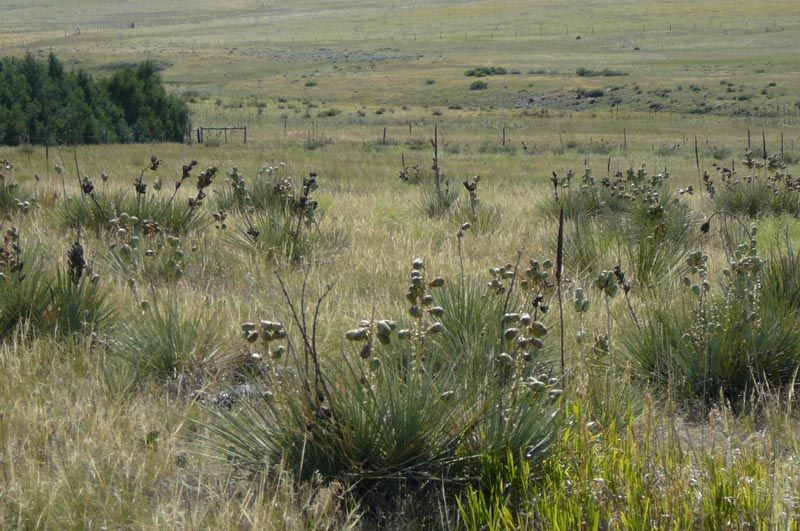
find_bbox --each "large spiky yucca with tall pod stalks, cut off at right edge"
[623,236,800,405]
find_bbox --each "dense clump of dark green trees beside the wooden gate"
[0,53,190,145]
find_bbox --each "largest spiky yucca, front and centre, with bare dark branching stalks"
[206,266,557,508]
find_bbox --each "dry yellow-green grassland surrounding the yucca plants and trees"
[0,0,800,529]
